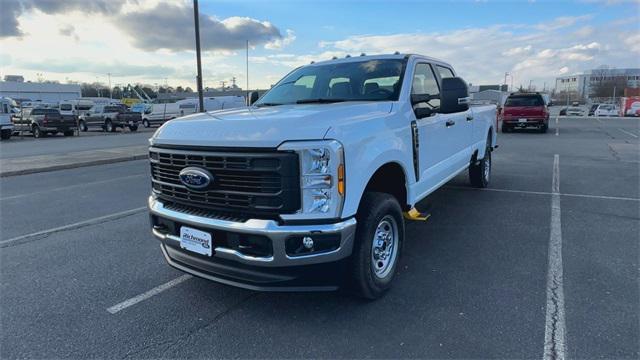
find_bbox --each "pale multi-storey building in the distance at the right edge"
[556,69,640,99]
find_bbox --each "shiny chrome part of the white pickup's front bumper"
[149,196,356,267]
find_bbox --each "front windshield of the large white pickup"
[255,59,405,106]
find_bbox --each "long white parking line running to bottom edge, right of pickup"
[543,154,566,360]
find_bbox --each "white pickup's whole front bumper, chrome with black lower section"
[149,196,356,291]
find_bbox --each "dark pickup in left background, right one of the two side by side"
[79,105,141,132]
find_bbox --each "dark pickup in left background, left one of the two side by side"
[13,107,77,138]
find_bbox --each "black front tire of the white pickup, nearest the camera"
[351,192,404,300]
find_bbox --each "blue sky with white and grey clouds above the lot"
[0,0,640,88]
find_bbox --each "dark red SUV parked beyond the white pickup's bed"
[502,93,549,133]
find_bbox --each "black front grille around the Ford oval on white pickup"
[149,147,300,218]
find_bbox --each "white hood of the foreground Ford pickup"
[150,102,393,148]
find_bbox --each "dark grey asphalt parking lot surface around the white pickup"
[0,118,640,359]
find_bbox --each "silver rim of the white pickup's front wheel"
[371,215,398,279]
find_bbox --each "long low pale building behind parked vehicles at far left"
[0,81,81,103]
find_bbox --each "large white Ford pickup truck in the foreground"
[148,54,497,299]
